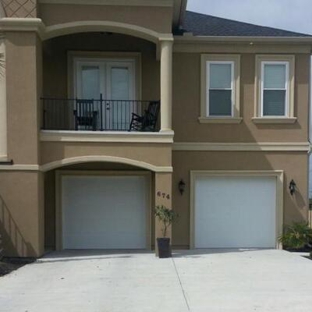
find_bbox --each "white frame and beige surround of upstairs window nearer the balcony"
[198,54,242,123]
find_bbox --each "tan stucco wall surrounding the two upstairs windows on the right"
[172,49,310,142]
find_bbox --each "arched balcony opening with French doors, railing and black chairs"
[42,30,160,132]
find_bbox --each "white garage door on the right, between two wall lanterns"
[194,176,276,248]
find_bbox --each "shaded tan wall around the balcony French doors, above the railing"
[43,33,160,100]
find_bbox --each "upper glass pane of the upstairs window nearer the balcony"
[209,64,232,89]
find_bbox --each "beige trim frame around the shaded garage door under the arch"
[55,170,152,251]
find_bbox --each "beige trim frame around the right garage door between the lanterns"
[190,170,284,249]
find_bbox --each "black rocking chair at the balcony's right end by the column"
[129,101,160,132]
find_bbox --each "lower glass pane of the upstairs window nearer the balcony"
[209,90,232,116]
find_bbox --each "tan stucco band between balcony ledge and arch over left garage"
[41,142,171,166]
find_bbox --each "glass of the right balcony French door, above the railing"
[111,67,130,100]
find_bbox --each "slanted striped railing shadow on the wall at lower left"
[0,196,35,257]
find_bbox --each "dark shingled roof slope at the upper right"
[183,11,311,37]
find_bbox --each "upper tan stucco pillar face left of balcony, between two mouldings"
[5,32,41,164]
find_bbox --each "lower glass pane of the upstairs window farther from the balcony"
[263,90,286,116]
